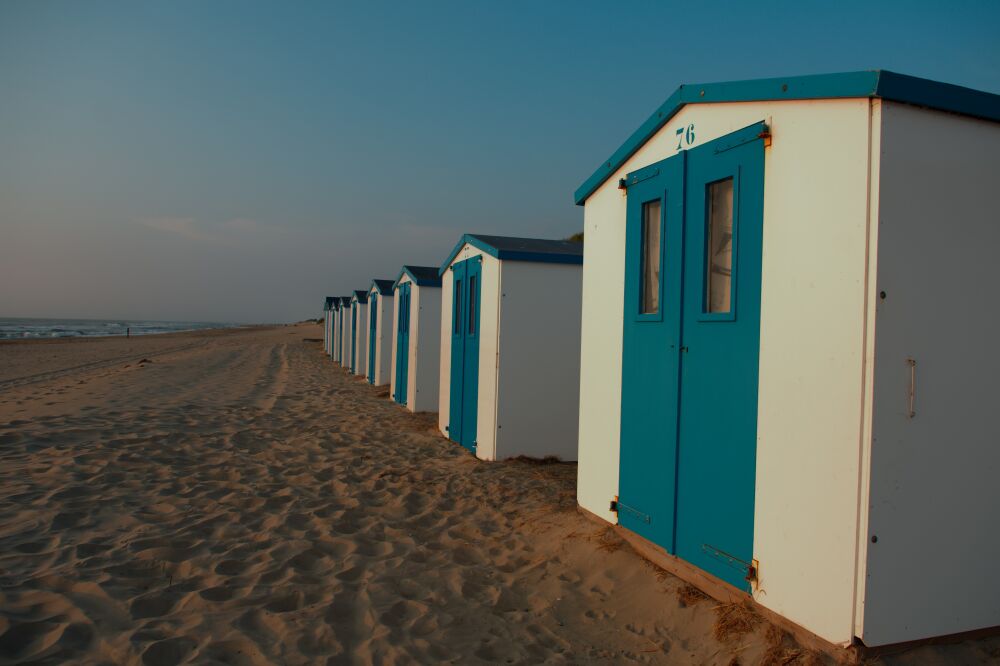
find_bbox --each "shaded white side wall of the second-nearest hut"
[496,261,582,460]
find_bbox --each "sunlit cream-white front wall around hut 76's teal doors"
[578,99,872,643]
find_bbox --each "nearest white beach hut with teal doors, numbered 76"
[575,71,1000,646]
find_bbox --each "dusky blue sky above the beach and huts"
[0,0,1000,323]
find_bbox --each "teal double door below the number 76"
[618,123,766,590]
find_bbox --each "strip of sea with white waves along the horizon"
[0,317,232,340]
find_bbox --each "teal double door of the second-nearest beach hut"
[448,257,483,452]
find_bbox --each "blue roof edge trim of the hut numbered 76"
[573,69,1000,205]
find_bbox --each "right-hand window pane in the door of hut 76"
[705,178,733,312]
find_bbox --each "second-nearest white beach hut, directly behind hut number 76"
[438,234,583,460]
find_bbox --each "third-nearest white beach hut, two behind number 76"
[389,266,441,412]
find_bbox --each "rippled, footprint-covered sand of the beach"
[0,326,1000,664]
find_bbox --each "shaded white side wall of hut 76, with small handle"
[861,102,1000,645]
